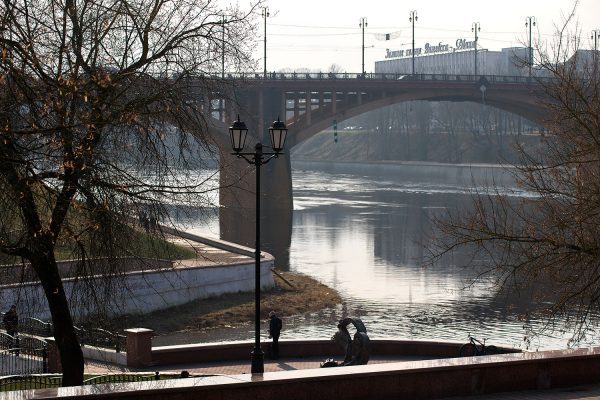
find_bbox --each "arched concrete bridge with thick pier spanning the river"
[213,73,550,264]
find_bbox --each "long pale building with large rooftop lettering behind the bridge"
[375,39,528,76]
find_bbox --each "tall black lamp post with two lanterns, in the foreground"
[229,116,287,374]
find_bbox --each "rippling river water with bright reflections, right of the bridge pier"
[172,163,592,349]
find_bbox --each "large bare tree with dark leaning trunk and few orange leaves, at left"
[0,0,260,385]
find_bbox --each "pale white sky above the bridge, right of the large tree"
[255,0,600,72]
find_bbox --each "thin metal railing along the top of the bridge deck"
[226,72,552,83]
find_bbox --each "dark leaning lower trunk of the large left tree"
[31,245,84,386]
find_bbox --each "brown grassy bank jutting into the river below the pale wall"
[115,271,342,345]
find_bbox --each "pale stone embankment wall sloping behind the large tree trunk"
[0,255,274,320]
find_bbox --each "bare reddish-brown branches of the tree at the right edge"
[431,12,600,342]
